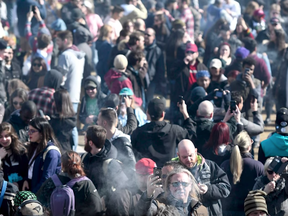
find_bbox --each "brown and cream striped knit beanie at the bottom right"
[244,190,268,216]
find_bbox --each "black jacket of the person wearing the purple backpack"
[36,173,102,216]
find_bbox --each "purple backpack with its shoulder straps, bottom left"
[50,174,89,216]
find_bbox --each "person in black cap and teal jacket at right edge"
[258,107,288,164]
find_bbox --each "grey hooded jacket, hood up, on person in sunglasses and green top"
[79,76,106,124]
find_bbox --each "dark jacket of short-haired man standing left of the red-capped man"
[145,41,165,84]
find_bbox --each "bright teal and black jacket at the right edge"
[258,133,288,164]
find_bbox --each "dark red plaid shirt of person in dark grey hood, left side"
[28,87,55,116]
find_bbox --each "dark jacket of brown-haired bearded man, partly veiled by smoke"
[82,140,128,197]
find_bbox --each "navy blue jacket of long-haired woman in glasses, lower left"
[31,141,61,193]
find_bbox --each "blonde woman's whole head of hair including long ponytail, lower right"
[230,131,251,184]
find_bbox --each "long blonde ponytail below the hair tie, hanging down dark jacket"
[230,145,243,184]
